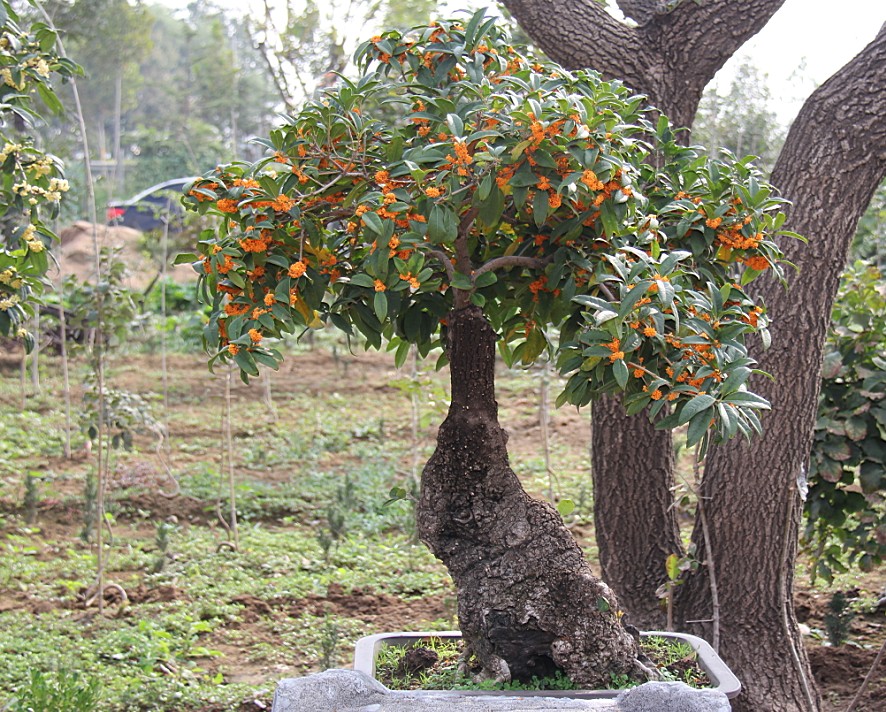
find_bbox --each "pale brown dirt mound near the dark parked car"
[50,220,197,291]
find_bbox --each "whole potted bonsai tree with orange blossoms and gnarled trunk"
[185,12,796,686]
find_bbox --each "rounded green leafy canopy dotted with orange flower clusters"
[185,11,796,442]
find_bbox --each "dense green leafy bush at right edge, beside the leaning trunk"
[803,261,886,581]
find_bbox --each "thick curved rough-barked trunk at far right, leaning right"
[678,25,886,712]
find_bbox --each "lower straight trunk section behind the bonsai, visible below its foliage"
[591,398,683,630]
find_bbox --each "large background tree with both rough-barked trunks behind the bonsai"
[503,0,886,710]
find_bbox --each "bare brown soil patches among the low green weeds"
[0,349,886,712]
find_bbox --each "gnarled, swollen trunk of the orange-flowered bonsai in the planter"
[417,307,637,687]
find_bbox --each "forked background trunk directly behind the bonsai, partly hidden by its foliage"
[503,0,784,627]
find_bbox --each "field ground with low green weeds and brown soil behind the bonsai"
[0,330,884,712]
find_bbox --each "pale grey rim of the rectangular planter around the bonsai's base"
[354,630,741,699]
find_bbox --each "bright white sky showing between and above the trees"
[163,0,886,122]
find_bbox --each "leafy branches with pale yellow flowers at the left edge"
[0,0,79,349]
